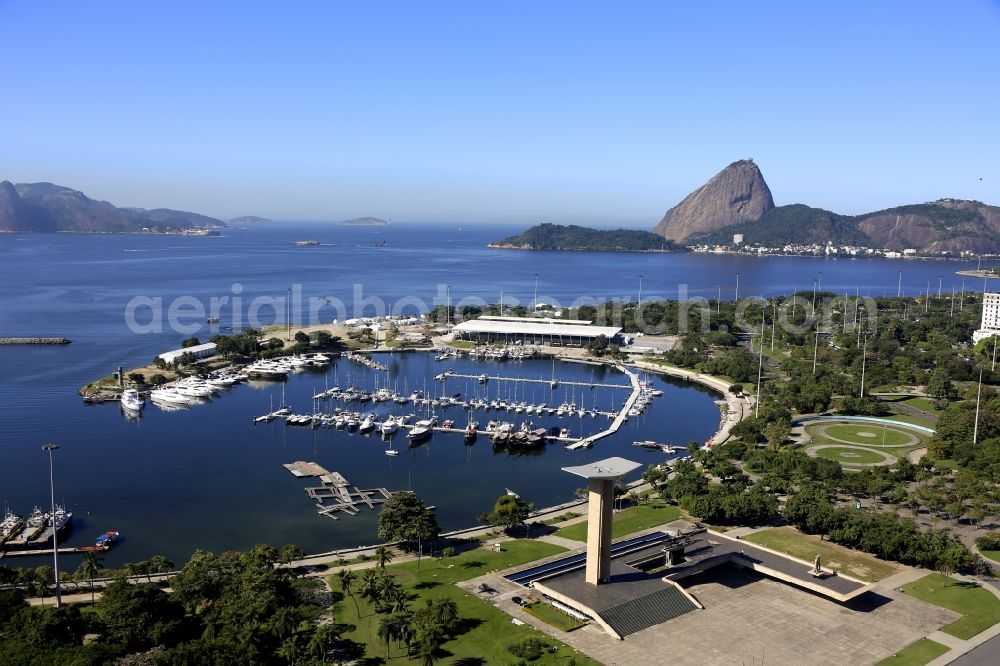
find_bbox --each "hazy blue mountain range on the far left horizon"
[0,180,226,233]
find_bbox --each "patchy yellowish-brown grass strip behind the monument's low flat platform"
[743,527,896,582]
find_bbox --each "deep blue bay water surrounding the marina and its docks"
[0,225,981,566]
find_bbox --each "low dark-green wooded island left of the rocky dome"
[488,223,687,252]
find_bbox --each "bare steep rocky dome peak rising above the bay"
[653,159,774,241]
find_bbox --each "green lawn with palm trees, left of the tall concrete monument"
[329,539,599,666]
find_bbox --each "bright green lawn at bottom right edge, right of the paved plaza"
[902,574,1000,640]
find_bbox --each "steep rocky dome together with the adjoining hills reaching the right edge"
[654,159,1000,254]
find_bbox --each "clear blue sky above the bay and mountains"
[0,0,1000,227]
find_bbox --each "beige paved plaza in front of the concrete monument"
[476,566,958,666]
